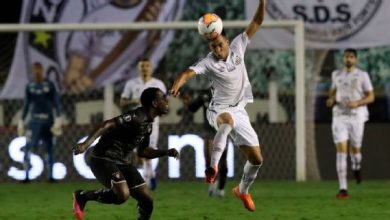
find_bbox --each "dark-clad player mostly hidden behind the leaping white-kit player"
[188,89,228,197]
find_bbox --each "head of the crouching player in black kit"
[141,87,169,115]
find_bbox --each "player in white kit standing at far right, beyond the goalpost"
[326,49,375,199]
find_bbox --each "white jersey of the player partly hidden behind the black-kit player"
[121,77,167,99]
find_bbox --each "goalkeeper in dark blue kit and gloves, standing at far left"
[18,63,62,183]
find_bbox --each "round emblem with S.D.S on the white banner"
[267,0,383,42]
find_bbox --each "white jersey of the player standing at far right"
[332,68,373,121]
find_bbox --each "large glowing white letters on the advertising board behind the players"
[7,134,234,180]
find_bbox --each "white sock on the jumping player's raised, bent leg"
[210,124,232,167]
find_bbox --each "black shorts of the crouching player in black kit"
[89,157,145,189]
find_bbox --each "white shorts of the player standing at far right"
[332,117,364,147]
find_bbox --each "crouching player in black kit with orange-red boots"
[73,88,179,220]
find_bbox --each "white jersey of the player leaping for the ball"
[189,32,253,105]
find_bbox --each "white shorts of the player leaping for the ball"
[207,103,260,147]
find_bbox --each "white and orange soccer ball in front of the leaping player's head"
[198,13,223,40]
